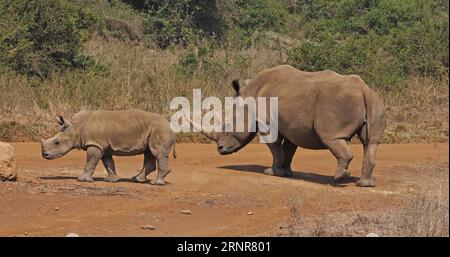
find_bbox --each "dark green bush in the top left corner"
[0,0,95,77]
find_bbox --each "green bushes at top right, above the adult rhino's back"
[288,0,449,88]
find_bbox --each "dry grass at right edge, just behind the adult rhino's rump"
[380,77,449,143]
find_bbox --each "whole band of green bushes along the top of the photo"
[0,0,449,89]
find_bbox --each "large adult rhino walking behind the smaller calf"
[194,65,386,187]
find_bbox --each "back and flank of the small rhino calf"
[81,109,171,155]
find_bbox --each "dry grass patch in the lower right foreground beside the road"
[278,162,449,237]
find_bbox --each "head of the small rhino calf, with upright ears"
[41,117,76,160]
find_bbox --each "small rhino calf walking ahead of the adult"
[41,110,176,185]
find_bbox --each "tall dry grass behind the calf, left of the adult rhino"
[0,37,280,142]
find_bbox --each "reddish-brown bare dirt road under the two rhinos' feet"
[0,143,449,236]
